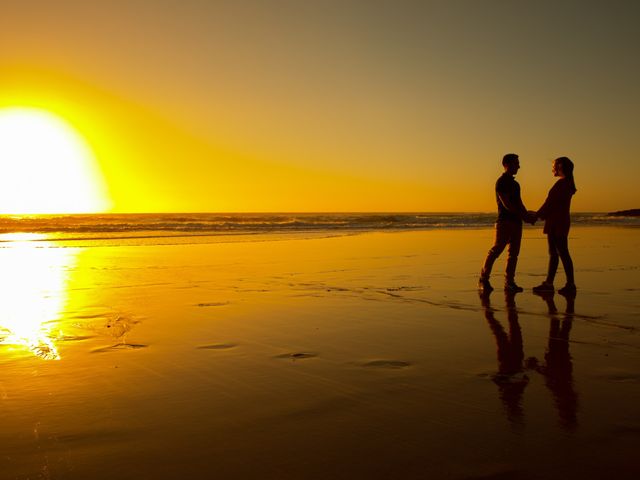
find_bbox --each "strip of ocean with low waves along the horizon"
[0,213,640,241]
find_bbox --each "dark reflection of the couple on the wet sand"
[480,291,578,430]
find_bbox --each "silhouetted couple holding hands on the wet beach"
[478,153,576,294]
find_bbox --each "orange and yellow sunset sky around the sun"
[0,0,640,212]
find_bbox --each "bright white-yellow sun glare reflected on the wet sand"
[0,233,78,360]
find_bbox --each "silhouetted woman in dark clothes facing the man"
[533,157,576,294]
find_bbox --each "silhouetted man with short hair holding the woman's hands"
[478,153,535,292]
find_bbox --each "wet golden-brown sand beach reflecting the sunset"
[0,227,640,480]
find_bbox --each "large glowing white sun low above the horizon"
[0,107,110,214]
